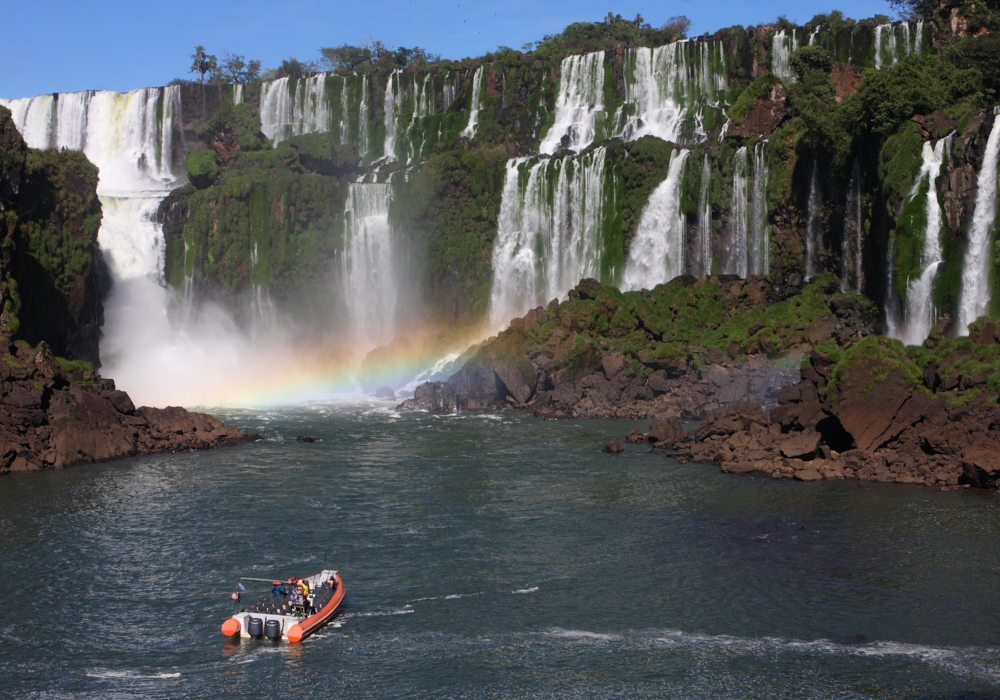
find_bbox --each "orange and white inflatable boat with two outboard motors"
[222,569,344,643]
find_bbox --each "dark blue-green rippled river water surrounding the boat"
[0,402,1000,698]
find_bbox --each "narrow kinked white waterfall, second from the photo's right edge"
[901,135,952,345]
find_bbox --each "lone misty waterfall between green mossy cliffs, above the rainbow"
[343,182,399,349]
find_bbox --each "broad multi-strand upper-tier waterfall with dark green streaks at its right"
[613,41,728,143]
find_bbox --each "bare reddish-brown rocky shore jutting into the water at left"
[0,342,260,474]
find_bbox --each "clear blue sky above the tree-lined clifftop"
[0,0,891,98]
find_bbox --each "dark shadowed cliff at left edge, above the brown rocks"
[0,107,108,366]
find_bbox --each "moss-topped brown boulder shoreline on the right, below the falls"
[397,278,1000,488]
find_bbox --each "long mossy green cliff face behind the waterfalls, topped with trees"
[152,10,992,342]
